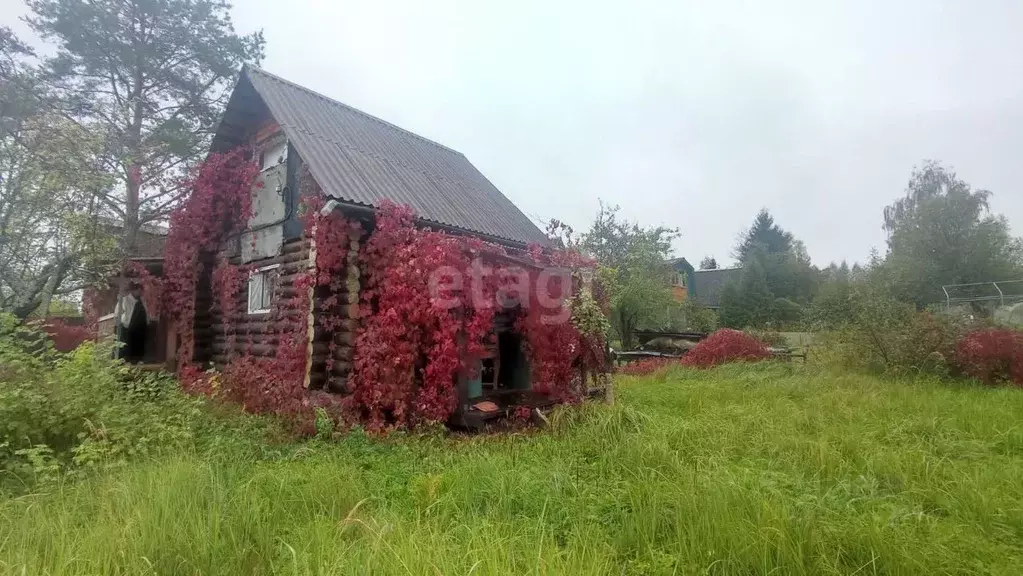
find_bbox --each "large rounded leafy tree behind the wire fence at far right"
[883,162,1023,308]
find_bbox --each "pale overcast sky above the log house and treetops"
[0,0,1023,265]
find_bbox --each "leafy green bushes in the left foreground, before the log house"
[0,317,263,492]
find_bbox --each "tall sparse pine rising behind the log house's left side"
[27,0,264,254]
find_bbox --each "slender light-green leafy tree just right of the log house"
[580,203,678,349]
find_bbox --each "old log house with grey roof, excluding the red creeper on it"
[128,65,601,426]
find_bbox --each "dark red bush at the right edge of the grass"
[955,328,1023,386]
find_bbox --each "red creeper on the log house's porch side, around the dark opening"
[345,203,606,430]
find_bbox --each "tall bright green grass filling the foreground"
[0,365,1023,576]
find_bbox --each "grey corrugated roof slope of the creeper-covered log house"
[234,67,547,243]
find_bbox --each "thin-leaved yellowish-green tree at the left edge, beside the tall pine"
[0,28,107,317]
